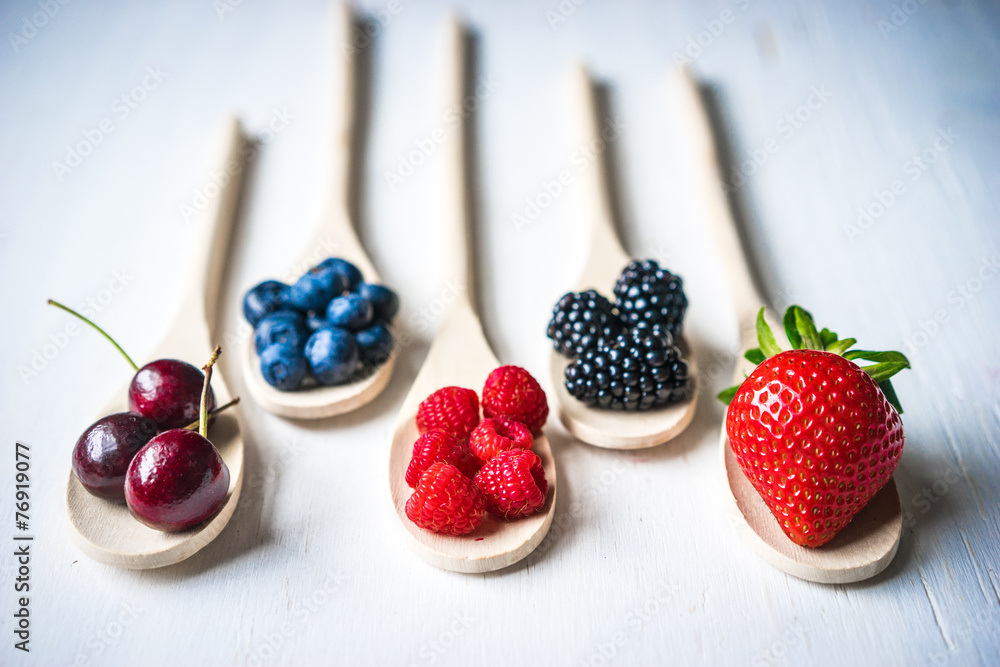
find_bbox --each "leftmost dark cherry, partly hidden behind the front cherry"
[73,412,157,503]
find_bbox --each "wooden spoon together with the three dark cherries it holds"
[60,118,249,569]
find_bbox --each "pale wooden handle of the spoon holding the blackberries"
[573,65,628,292]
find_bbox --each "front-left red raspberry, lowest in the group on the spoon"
[406,461,486,535]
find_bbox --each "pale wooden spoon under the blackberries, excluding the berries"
[549,66,698,449]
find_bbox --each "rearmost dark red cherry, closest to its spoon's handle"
[128,359,215,431]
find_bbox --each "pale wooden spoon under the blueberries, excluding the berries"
[243,3,396,419]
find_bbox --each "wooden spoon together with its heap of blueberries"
[243,3,399,419]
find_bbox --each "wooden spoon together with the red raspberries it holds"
[388,18,556,573]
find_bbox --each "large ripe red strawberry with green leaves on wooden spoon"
[720,306,909,547]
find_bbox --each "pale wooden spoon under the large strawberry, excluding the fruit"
[673,65,902,584]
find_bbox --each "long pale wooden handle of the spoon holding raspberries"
[441,15,475,308]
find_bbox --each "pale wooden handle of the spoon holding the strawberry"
[675,69,764,340]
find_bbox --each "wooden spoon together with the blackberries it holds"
[548,67,698,449]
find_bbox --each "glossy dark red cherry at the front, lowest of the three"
[125,429,229,531]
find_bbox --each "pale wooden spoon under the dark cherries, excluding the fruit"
[66,118,248,570]
